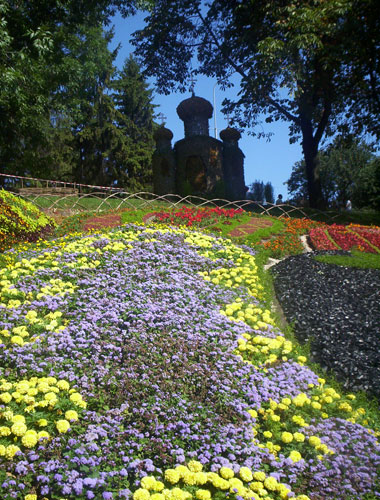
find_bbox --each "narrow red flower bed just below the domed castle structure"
[152,207,243,227]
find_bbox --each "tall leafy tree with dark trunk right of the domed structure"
[134,0,380,206]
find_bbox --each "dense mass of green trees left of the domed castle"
[0,0,157,188]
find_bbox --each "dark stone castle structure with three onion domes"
[153,95,246,200]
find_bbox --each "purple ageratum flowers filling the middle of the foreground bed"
[4,227,374,498]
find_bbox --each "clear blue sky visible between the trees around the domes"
[110,13,302,199]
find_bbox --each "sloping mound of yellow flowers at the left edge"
[0,189,54,252]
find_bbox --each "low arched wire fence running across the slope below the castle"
[0,174,339,222]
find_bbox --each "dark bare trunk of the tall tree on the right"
[301,119,325,210]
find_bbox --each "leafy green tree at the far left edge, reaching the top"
[0,0,135,178]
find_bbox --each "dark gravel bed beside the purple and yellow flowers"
[271,252,380,398]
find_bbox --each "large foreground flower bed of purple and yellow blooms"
[0,225,380,500]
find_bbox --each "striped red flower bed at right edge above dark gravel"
[309,224,380,253]
